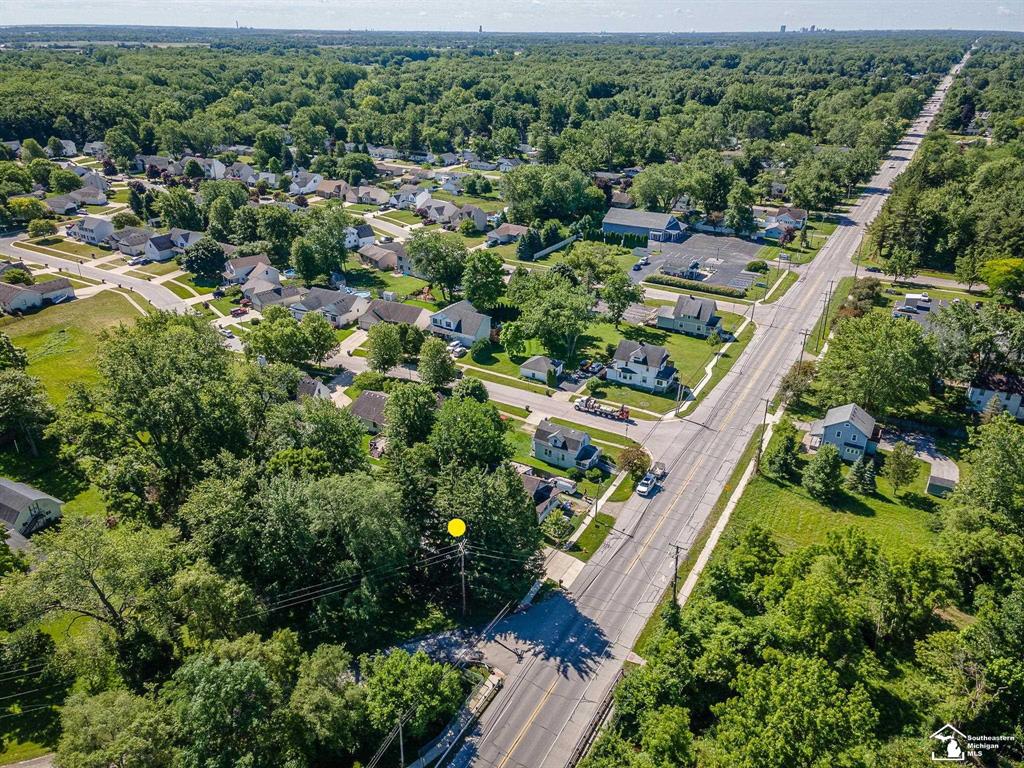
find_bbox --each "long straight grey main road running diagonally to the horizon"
[453,51,959,768]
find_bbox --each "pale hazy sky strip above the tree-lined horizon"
[0,0,1024,32]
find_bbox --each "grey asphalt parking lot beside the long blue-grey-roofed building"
[648,234,761,291]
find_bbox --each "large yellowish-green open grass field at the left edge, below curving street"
[0,291,139,402]
